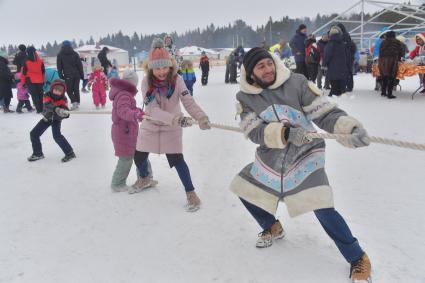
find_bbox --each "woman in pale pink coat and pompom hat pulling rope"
[133,39,211,211]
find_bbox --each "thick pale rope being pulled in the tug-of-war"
[71,111,425,151]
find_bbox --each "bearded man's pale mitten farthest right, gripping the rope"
[334,116,370,148]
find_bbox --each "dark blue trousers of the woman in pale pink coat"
[134,150,195,192]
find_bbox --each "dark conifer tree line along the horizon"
[0,4,425,56]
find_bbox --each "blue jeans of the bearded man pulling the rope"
[241,199,364,262]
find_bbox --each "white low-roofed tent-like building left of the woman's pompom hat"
[75,45,129,66]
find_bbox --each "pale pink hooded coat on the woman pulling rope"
[137,75,207,154]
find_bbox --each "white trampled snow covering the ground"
[0,67,425,283]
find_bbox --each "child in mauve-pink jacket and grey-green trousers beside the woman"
[109,70,152,192]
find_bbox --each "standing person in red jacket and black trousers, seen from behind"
[21,46,45,113]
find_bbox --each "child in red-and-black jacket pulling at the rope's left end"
[28,80,76,162]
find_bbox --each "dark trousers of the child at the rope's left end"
[30,119,73,155]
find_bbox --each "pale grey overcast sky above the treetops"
[0,0,424,46]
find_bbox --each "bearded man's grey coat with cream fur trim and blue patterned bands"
[230,57,361,220]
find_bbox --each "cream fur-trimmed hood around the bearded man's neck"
[240,54,291,94]
